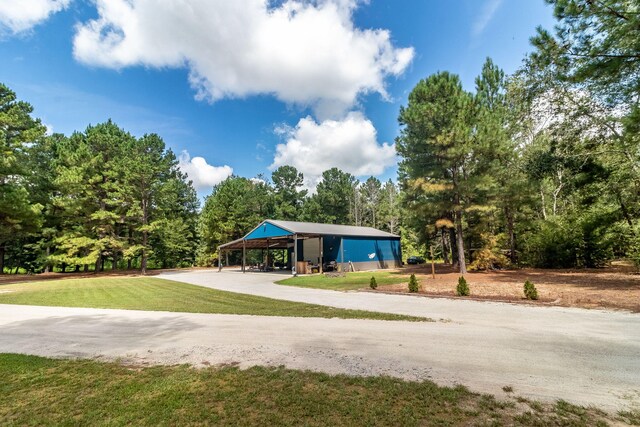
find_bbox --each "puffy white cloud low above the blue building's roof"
[269,112,397,190]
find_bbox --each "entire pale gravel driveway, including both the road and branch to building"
[0,271,640,410]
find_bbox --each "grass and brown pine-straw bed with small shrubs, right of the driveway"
[278,264,640,312]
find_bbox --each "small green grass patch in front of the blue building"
[276,271,409,291]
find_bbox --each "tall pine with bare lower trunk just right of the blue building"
[396,72,480,274]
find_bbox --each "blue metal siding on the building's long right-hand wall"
[338,237,401,265]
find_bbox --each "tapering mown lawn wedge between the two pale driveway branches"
[0,277,429,321]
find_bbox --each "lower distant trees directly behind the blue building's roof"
[198,165,401,265]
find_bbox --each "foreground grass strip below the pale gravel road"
[0,354,627,426]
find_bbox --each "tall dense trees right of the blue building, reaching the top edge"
[397,0,640,273]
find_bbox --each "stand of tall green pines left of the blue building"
[0,90,199,272]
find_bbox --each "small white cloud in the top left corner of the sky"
[0,0,71,34]
